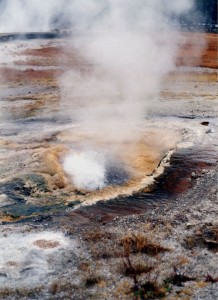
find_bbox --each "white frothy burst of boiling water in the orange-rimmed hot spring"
[63,151,106,190]
